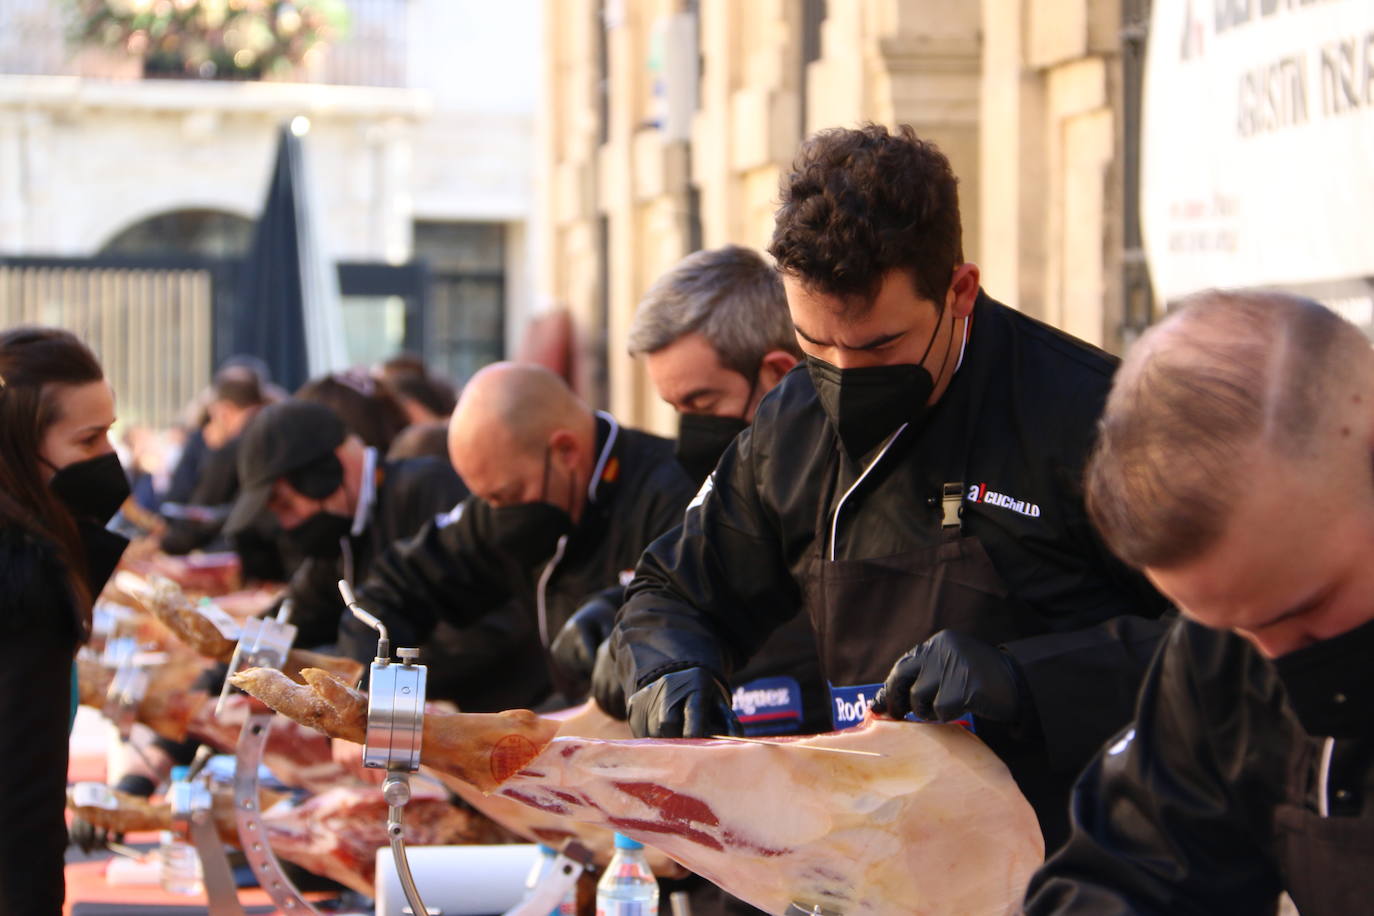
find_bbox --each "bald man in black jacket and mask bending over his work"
[339,363,695,702]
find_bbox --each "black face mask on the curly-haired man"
[807,304,954,463]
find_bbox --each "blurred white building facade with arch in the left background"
[0,0,541,398]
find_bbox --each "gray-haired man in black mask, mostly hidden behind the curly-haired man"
[552,244,830,735]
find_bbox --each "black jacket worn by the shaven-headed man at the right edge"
[1026,621,1374,916]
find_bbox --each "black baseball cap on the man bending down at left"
[224,398,348,534]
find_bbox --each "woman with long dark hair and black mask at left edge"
[0,327,129,916]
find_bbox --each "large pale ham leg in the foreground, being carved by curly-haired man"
[235,669,1044,916]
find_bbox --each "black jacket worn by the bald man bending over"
[339,412,692,700]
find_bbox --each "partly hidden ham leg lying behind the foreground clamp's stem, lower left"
[67,781,507,897]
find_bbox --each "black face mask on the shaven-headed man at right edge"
[1274,622,1374,737]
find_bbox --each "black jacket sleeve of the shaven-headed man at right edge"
[1025,623,1281,916]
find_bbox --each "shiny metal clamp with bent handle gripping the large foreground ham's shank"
[339,580,430,913]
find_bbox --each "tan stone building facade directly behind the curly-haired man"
[536,0,1143,431]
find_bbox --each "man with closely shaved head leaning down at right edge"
[1026,293,1374,916]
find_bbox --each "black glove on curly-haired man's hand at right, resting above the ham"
[872,630,1031,729]
